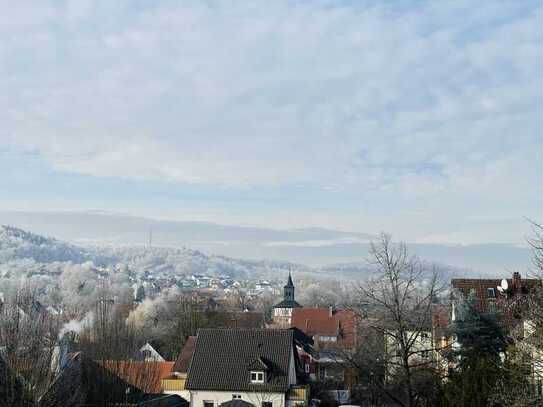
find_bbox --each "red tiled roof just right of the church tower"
[291,308,358,349]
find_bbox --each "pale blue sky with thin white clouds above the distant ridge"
[0,0,543,244]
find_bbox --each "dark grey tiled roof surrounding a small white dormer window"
[187,329,295,392]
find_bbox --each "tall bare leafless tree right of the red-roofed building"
[358,234,443,407]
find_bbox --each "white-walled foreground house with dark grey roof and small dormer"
[186,329,308,407]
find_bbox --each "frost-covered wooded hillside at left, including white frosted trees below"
[0,226,311,309]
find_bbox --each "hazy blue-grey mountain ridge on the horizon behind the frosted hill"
[0,210,532,276]
